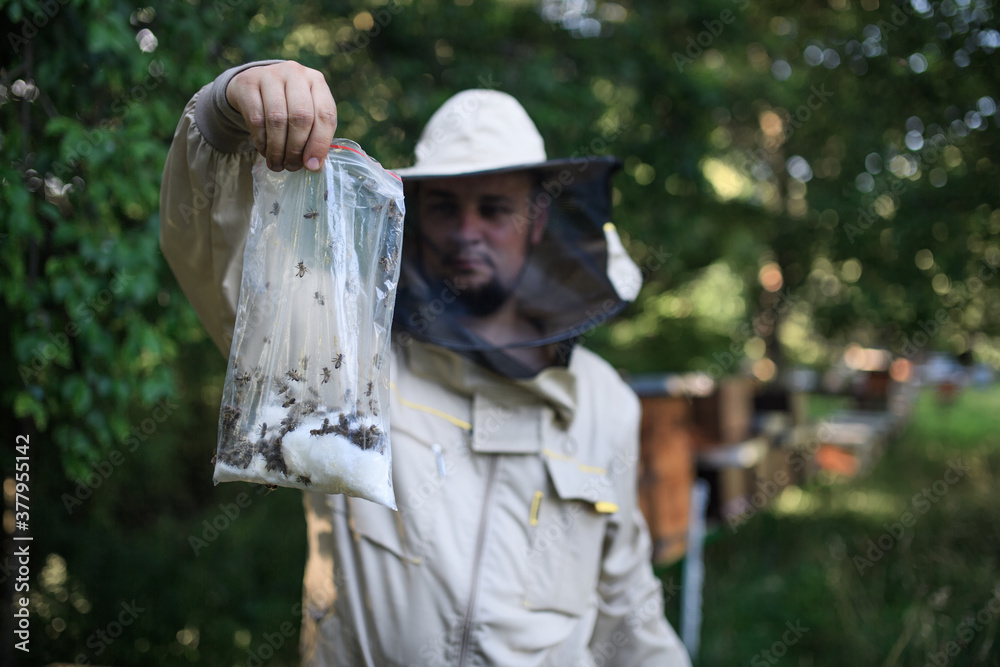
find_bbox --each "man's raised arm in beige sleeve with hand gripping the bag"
[160,62,337,356]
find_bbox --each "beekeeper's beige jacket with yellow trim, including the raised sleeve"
[160,71,690,667]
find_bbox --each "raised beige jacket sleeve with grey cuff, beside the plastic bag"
[160,61,280,357]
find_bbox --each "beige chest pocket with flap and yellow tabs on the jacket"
[523,450,618,616]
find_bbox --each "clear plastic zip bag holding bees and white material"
[214,139,404,509]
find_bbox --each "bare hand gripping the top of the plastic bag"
[226,61,337,171]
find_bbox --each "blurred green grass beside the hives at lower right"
[664,387,1000,667]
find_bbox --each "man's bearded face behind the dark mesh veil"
[417,172,544,315]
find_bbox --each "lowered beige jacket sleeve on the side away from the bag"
[590,387,691,667]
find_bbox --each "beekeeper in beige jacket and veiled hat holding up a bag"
[160,62,689,667]
